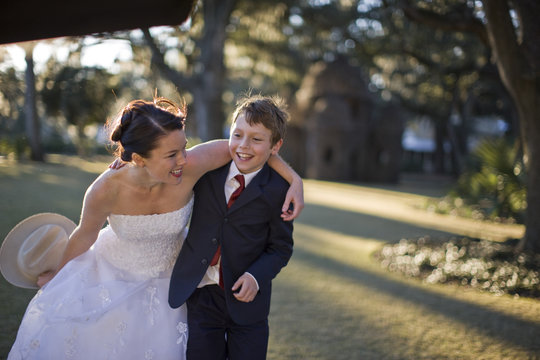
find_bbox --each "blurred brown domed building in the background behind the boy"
[281,59,403,182]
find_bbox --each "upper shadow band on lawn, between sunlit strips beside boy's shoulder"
[297,203,456,243]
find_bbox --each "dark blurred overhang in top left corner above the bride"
[0,0,194,44]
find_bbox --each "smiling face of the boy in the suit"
[229,114,283,174]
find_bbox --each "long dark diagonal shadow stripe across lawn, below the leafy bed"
[294,243,540,354]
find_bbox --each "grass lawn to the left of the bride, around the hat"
[0,155,110,359]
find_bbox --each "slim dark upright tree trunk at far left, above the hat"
[24,45,45,161]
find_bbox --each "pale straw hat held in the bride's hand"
[0,213,76,289]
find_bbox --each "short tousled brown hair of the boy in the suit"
[232,95,289,146]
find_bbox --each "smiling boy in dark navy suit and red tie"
[169,96,293,360]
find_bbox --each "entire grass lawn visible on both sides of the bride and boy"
[0,156,540,360]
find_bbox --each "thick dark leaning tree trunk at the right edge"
[483,0,540,254]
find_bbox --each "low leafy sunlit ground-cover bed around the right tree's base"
[375,237,540,298]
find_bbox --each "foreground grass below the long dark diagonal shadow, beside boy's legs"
[270,261,530,360]
